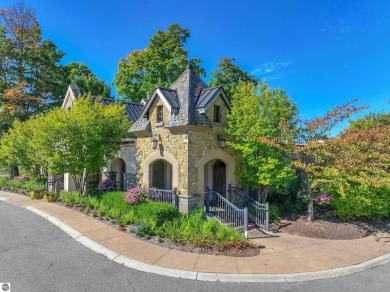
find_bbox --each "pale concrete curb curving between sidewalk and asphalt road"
[15,206,390,283]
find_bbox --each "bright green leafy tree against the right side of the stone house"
[226,82,297,202]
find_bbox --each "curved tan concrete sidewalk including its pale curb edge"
[0,191,390,282]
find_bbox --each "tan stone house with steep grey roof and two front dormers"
[63,64,239,212]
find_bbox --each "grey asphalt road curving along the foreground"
[0,201,390,292]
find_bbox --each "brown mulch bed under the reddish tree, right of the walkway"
[271,214,390,240]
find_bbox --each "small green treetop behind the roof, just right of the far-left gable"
[65,62,111,97]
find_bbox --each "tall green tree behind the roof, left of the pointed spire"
[113,23,205,102]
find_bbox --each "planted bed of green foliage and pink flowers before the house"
[53,188,259,256]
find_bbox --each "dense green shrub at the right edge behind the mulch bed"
[328,185,390,219]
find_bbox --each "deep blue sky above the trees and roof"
[1,0,390,125]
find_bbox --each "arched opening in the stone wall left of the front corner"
[149,159,172,190]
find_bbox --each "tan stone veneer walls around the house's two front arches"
[136,97,239,212]
